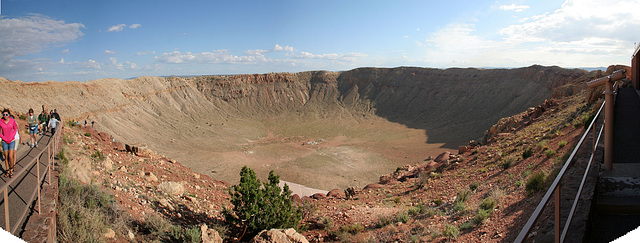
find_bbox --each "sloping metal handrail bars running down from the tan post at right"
[515,99,606,242]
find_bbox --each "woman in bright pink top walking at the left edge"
[0,109,19,178]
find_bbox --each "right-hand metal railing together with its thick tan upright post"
[515,71,624,243]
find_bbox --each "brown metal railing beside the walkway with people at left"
[0,122,63,237]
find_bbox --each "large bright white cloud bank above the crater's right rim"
[418,0,640,67]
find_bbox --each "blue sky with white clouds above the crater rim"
[0,0,640,81]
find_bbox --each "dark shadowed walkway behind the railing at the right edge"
[585,87,640,242]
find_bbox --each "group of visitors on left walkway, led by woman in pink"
[0,105,60,178]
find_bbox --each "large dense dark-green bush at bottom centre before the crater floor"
[223,166,302,237]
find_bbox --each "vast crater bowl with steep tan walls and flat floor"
[0,66,586,190]
